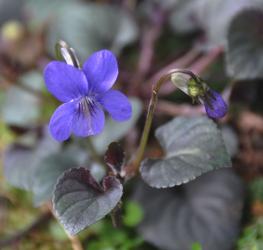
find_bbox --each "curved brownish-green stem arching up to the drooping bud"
[126,69,199,177]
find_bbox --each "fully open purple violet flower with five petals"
[44,50,132,141]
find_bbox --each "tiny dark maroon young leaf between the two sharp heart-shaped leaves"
[104,142,125,174]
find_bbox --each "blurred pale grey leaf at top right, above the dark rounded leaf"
[170,0,263,48]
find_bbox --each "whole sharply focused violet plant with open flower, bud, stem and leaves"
[33,41,231,235]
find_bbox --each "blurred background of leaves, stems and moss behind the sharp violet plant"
[0,0,263,250]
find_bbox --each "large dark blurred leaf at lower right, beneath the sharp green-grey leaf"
[134,168,245,250]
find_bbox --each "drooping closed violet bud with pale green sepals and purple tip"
[171,70,227,119]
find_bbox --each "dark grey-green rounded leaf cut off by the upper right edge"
[227,9,263,80]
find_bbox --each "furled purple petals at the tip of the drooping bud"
[200,89,227,119]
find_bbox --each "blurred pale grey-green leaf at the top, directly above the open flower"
[48,3,138,62]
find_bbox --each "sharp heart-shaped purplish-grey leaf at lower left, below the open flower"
[53,168,123,235]
